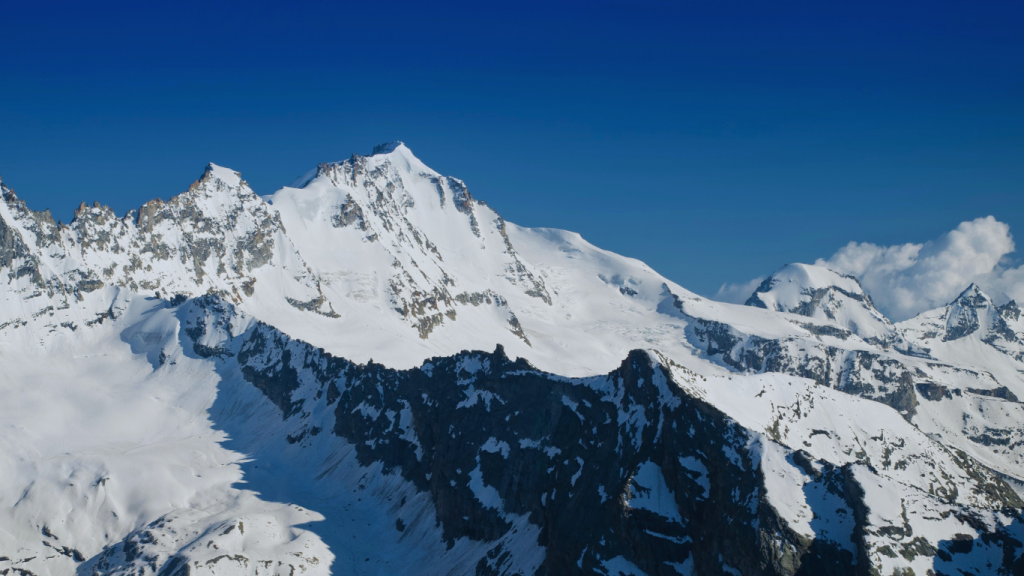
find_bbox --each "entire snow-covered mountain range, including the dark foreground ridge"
[0,142,1024,576]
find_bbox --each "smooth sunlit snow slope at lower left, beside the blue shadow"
[0,294,333,575]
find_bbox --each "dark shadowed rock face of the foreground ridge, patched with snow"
[334,349,798,574]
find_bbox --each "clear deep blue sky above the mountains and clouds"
[0,0,1024,294]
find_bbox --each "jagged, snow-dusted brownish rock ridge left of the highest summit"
[0,165,329,323]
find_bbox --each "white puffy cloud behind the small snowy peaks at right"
[716,216,1024,322]
